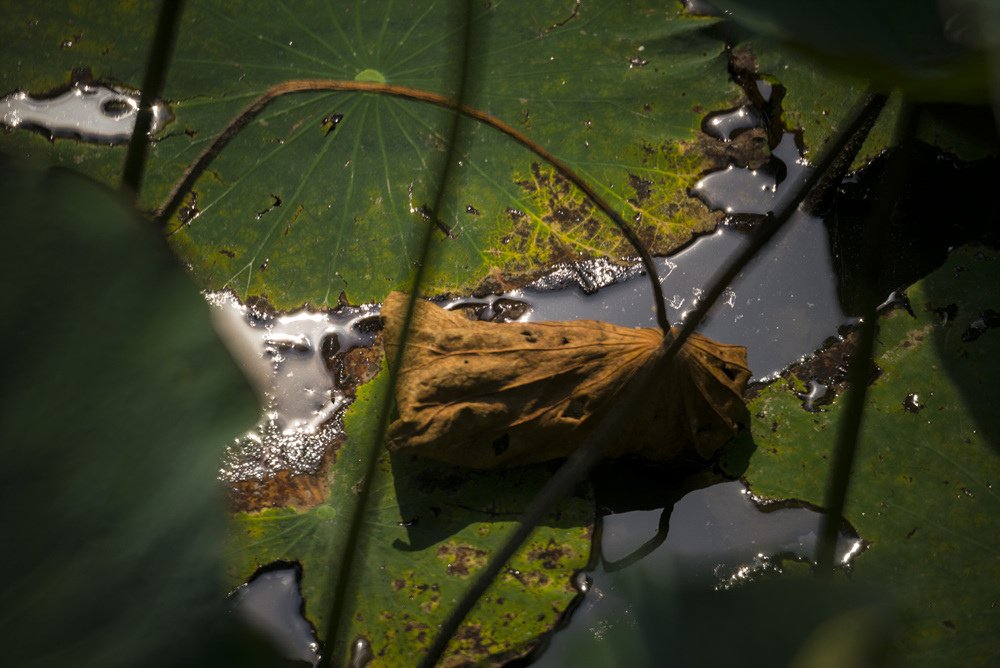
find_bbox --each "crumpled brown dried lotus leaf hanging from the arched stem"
[382,292,750,469]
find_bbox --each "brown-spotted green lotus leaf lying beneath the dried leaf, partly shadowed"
[229,373,594,666]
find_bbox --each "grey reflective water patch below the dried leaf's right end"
[534,481,863,666]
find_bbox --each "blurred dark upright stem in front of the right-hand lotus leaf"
[816,103,915,574]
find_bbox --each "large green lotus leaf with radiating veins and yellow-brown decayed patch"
[0,0,738,308]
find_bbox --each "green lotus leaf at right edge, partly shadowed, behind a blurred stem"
[730,248,1000,666]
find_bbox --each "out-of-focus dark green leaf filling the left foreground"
[0,156,259,667]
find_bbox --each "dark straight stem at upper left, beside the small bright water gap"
[121,0,184,198]
